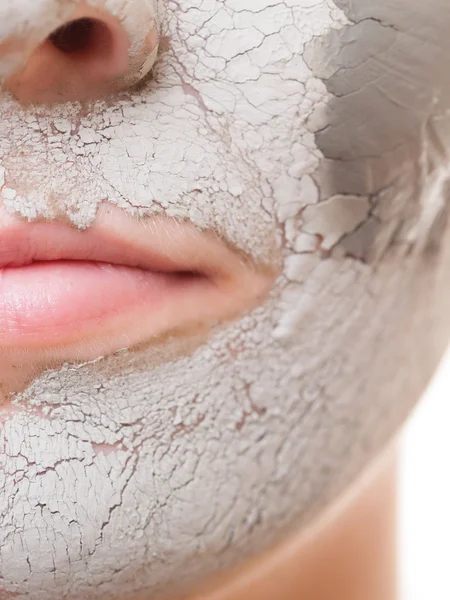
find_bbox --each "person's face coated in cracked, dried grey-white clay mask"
[0,0,450,600]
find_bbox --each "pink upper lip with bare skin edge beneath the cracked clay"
[0,207,253,280]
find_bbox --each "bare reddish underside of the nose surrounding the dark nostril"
[2,3,158,104]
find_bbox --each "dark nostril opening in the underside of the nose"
[49,18,99,55]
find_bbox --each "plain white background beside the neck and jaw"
[399,351,450,600]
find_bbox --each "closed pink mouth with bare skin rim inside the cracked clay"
[0,205,274,360]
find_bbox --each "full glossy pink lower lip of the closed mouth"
[0,261,203,349]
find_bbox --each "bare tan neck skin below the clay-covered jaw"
[183,449,397,600]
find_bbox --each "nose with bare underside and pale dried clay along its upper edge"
[0,0,158,104]
